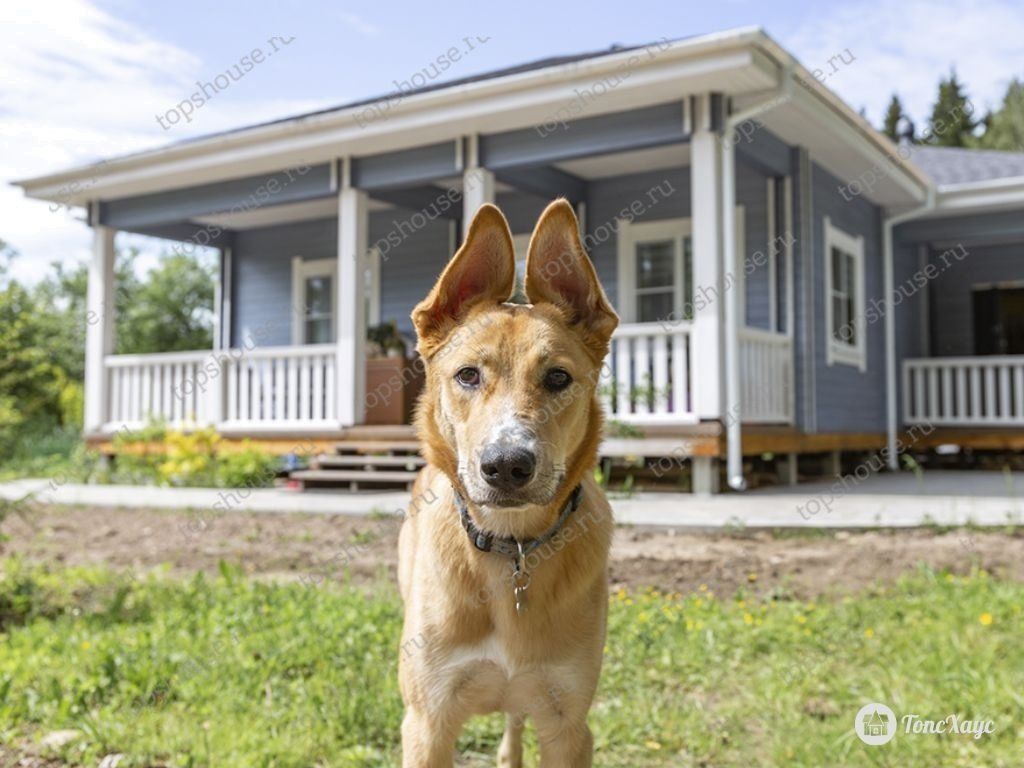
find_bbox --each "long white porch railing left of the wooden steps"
[104,344,338,431]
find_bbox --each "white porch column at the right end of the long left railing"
[336,161,370,427]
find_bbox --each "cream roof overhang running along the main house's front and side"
[15,29,929,208]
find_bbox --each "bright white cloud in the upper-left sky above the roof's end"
[0,0,312,282]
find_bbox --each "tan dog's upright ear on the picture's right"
[525,200,618,356]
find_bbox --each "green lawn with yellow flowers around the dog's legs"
[0,560,1024,768]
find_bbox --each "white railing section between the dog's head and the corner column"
[601,323,696,424]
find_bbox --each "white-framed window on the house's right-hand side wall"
[824,216,867,371]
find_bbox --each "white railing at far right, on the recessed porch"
[903,355,1024,426]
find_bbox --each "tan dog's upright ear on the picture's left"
[413,204,515,357]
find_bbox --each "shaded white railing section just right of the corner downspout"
[739,328,794,424]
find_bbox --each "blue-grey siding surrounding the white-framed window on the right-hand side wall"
[811,165,886,432]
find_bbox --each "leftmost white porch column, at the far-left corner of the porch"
[84,225,117,434]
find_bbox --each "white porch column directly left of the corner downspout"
[690,96,735,419]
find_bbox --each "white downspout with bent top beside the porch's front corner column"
[721,73,794,490]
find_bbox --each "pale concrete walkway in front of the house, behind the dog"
[0,471,1024,529]
